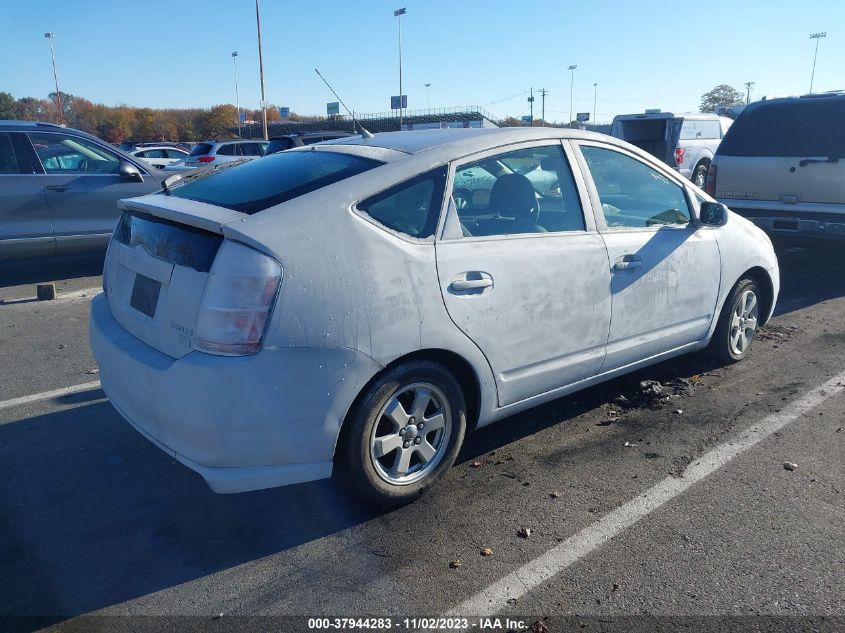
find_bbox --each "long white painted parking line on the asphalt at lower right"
[448,372,845,616]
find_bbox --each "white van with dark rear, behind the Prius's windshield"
[610,112,732,189]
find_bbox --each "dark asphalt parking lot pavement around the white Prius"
[0,243,845,631]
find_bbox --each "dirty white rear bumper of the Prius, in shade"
[90,295,380,493]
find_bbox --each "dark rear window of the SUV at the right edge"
[718,97,845,158]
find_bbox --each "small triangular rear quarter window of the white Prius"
[358,165,447,238]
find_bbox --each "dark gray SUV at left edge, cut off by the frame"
[0,121,167,260]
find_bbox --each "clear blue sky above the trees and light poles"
[0,0,845,121]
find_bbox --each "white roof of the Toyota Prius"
[320,127,607,154]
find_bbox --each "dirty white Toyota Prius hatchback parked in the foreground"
[90,128,779,504]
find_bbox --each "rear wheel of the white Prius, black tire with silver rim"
[337,361,466,506]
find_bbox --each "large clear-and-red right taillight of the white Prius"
[195,240,282,356]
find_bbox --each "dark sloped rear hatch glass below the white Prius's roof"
[169,151,382,215]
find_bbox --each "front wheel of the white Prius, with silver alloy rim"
[708,277,763,365]
